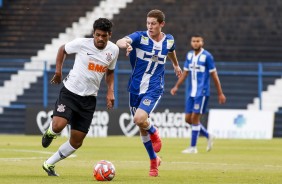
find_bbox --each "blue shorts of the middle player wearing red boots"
[129,93,162,116]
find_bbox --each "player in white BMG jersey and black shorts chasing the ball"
[42,18,119,176]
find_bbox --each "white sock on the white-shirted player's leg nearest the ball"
[46,141,76,165]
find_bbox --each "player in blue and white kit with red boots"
[117,10,182,176]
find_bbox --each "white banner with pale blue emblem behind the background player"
[208,109,274,139]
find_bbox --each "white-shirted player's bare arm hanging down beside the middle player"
[106,70,115,109]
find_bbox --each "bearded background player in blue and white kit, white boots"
[170,34,226,153]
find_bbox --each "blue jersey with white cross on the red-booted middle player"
[127,31,175,95]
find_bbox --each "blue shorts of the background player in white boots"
[185,96,209,114]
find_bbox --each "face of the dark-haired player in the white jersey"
[93,29,112,50]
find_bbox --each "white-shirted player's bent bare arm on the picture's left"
[50,45,67,84]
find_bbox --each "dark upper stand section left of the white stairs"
[0,0,99,59]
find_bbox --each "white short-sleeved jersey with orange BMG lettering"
[63,38,119,96]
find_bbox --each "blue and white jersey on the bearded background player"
[184,48,216,97]
